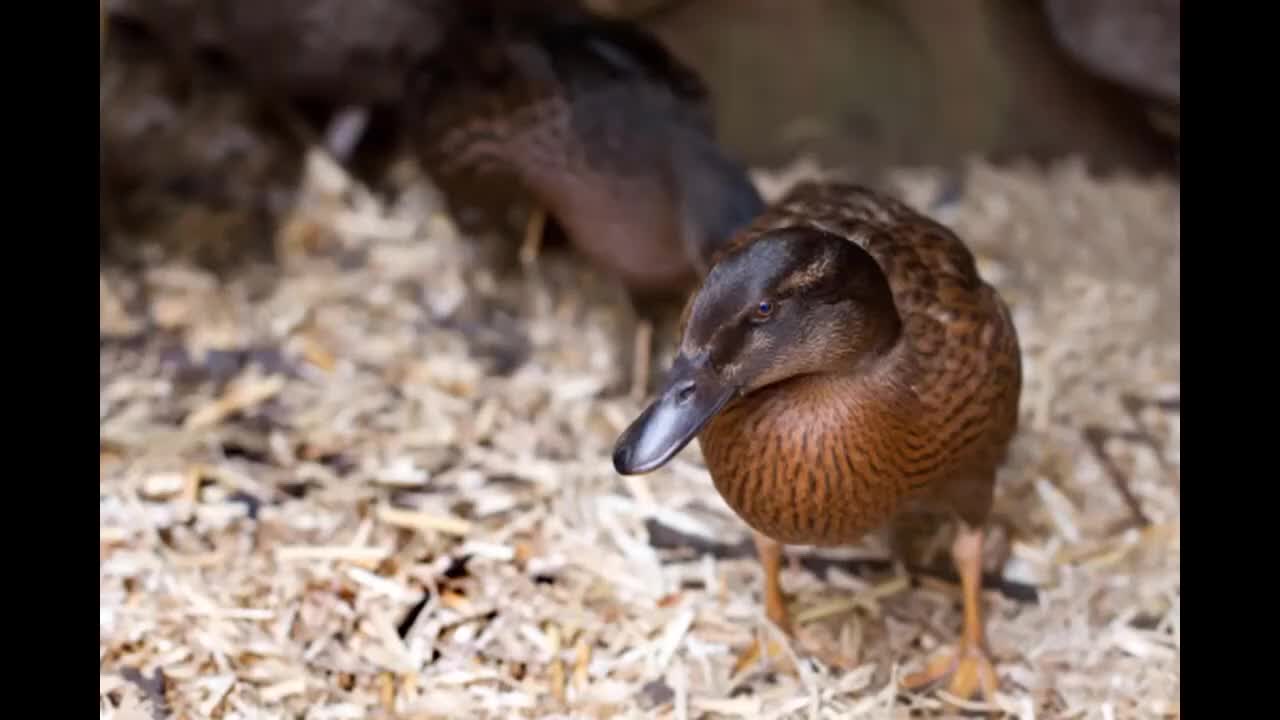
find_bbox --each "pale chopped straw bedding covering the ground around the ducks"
[99,137,1180,720]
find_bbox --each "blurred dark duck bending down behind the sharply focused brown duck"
[402,3,764,398]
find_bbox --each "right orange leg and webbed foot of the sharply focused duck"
[902,525,997,702]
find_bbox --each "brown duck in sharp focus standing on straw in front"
[613,183,1021,698]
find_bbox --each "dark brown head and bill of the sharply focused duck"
[613,227,901,475]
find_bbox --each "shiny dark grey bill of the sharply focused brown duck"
[613,354,737,475]
